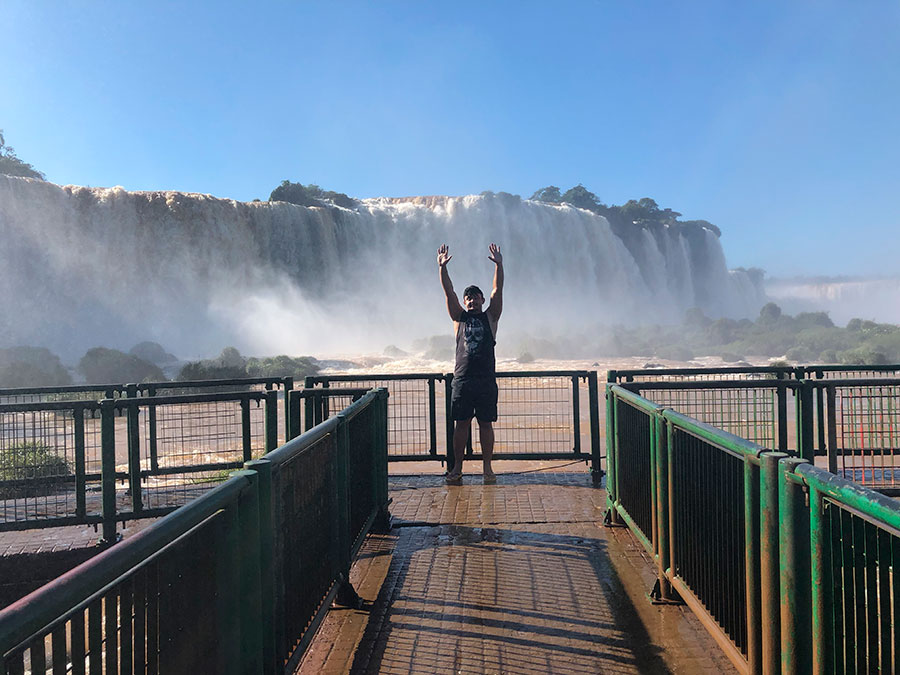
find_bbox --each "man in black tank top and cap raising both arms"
[438,244,503,485]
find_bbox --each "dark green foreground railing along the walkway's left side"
[0,391,387,675]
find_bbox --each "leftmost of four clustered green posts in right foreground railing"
[744,455,763,673]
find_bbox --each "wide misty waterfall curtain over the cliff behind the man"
[0,176,765,358]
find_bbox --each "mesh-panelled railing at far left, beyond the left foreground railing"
[0,391,277,541]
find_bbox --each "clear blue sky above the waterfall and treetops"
[0,0,900,276]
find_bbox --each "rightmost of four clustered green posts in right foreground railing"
[809,487,832,675]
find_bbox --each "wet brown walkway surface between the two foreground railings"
[299,472,735,673]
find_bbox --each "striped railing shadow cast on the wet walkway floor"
[342,523,670,673]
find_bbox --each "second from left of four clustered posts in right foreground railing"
[759,452,787,675]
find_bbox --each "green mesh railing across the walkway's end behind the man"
[305,370,603,480]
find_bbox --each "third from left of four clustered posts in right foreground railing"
[778,457,812,675]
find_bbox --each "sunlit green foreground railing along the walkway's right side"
[607,384,900,673]
